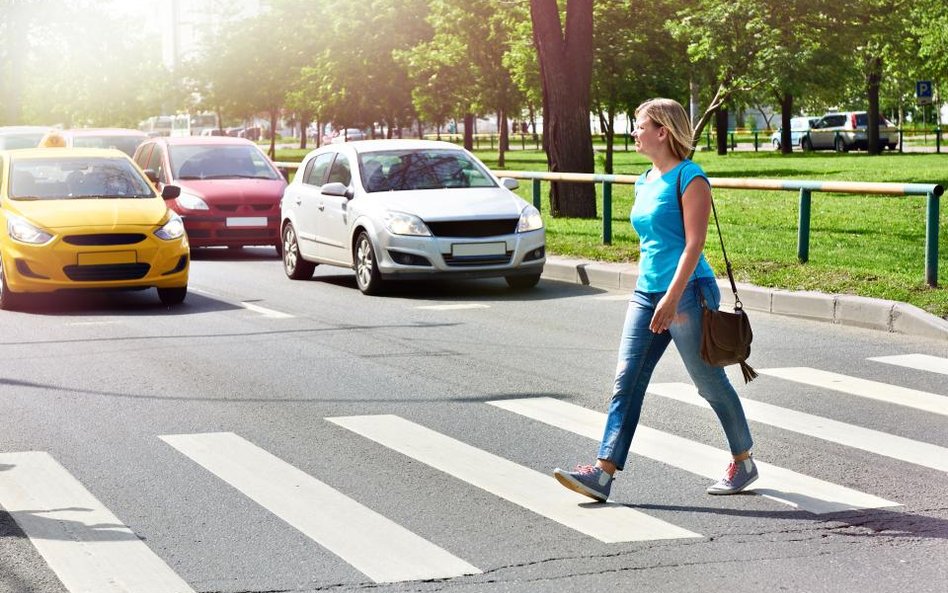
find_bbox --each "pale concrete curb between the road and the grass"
[543,257,948,340]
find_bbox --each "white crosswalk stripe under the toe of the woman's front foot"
[327,415,701,543]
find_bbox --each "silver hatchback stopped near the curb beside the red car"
[281,140,546,294]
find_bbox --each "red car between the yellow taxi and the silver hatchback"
[134,136,286,254]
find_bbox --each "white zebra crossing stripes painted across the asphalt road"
[0,355,948,593]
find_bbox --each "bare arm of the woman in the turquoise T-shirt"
[649,177,711,333]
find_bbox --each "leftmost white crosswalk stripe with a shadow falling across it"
[0,452,193,593]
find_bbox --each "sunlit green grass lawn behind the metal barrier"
[277,145,948,318]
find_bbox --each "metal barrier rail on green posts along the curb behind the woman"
[494,171,944,288]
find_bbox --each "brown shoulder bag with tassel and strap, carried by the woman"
[677,172,757,383]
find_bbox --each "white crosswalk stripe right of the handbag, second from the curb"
[758,367,948,416]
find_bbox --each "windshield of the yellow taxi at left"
[9,156,155,200]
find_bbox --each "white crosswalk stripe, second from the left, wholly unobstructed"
[160,433,481,583]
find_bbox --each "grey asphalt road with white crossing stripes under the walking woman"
[0,248,948,593]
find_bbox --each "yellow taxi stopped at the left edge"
[0,148,190,309]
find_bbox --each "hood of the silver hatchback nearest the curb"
[365,187,528,221]
